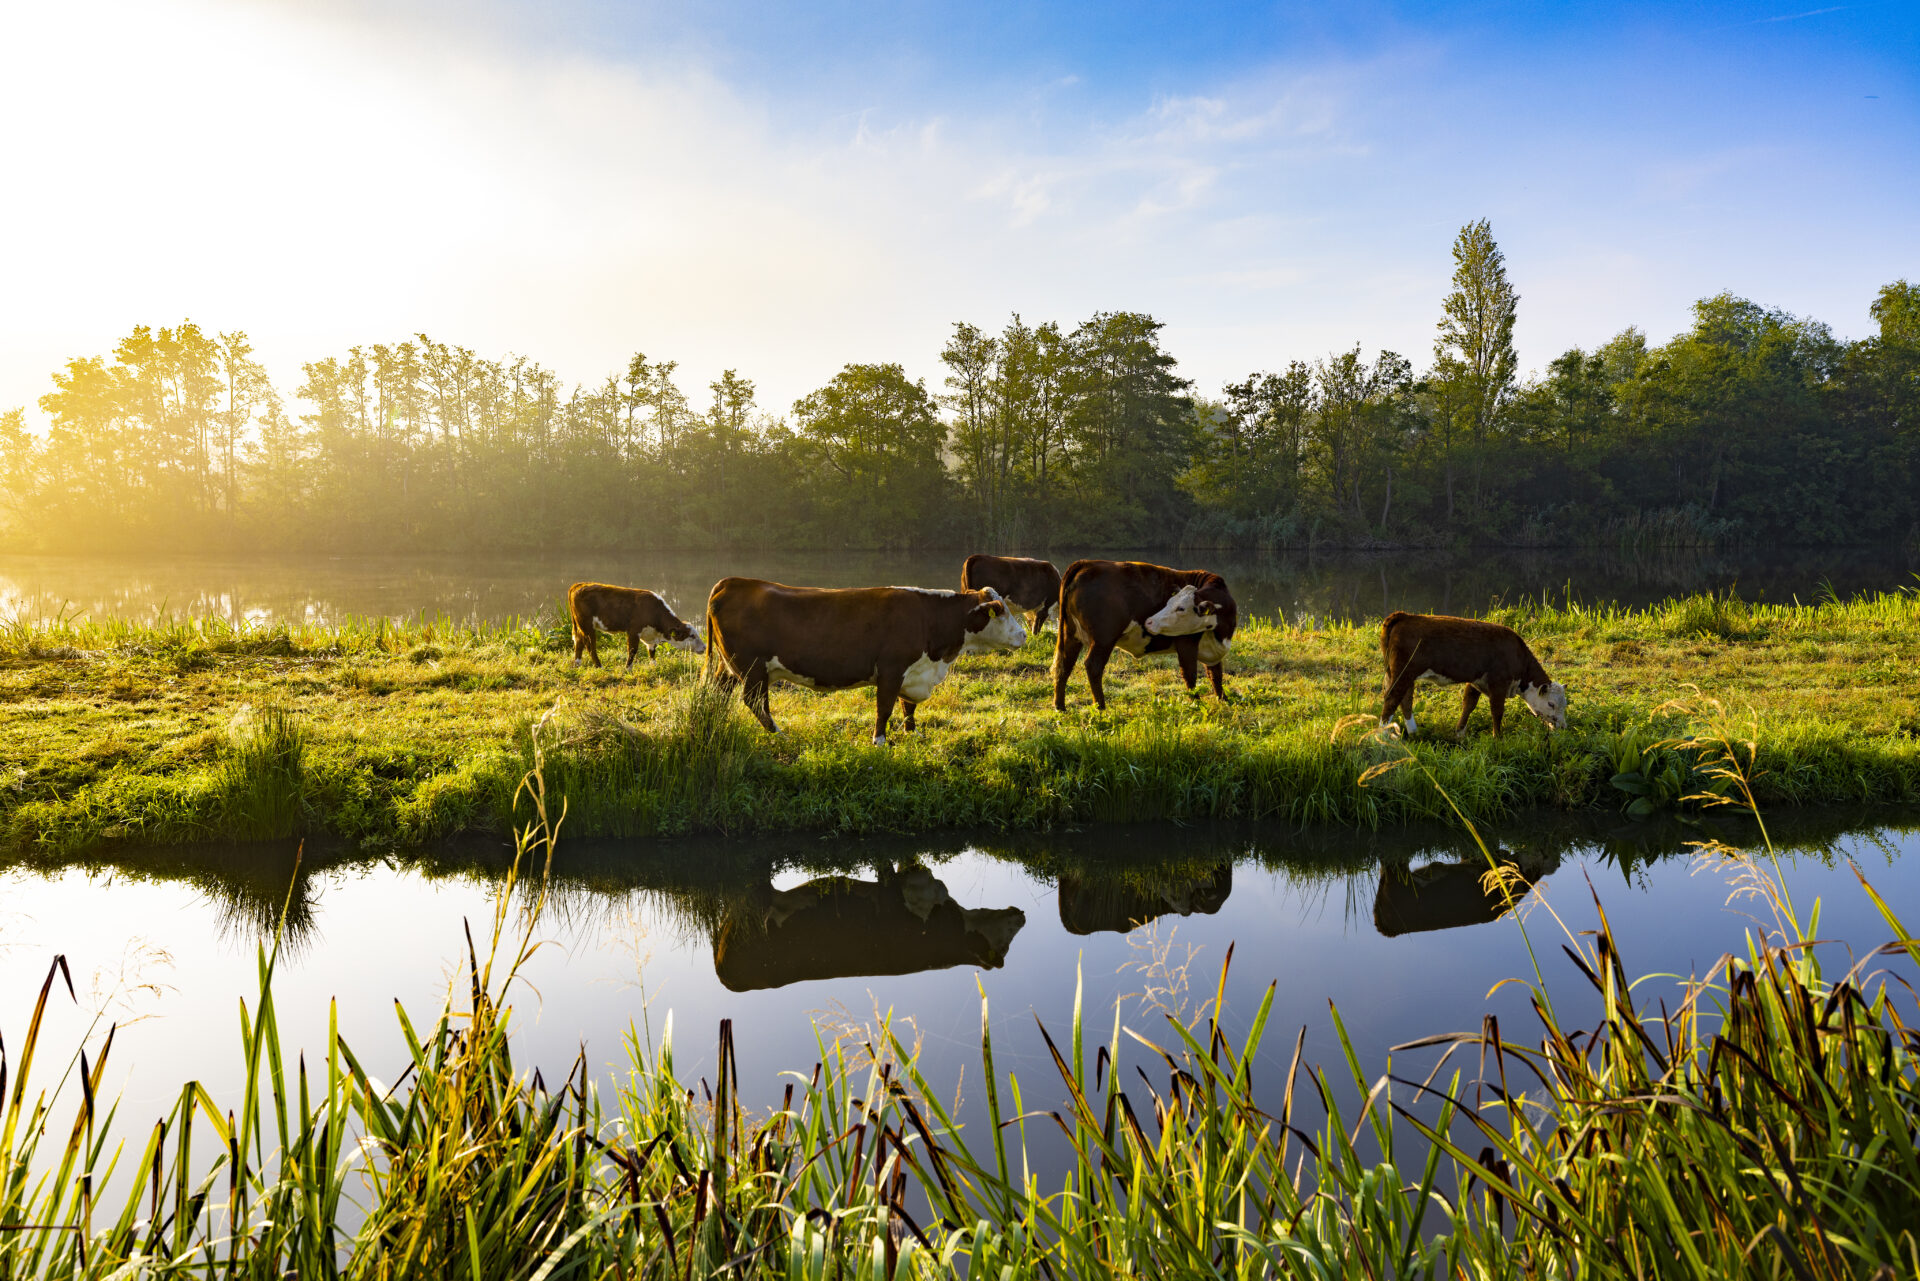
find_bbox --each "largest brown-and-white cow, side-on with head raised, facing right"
[707,578,1027,747]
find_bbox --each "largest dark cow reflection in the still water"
[714,864,1027,991]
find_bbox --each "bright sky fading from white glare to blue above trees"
[0,0,1920,413]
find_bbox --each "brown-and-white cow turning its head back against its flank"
[1054,561,1240,711]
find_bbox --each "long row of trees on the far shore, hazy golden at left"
[0,221,1920,551]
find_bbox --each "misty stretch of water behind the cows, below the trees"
[0,547,1920,622]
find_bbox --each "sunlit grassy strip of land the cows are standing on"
[0,592,1920,855]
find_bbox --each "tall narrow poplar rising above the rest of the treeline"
[1434,219,1521,520]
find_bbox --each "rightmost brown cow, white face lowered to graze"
[1380,609,1567,737]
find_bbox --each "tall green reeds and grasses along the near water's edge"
[0,775,1920,1281]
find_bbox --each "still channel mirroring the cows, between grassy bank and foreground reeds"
[0,812,1920,1175]
